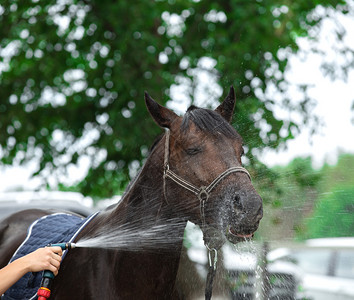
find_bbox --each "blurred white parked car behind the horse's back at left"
[0,191,93,220]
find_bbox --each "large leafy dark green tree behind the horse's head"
[0,0,349,197]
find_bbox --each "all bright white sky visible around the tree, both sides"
[0,5,354,192]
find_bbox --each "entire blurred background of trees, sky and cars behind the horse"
[0,0,354,300]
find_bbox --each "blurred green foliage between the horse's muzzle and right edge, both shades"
[261,154,354,239]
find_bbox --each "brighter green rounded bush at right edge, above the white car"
[306,186,354,238]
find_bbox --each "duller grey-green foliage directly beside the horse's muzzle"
[259,157,323,240]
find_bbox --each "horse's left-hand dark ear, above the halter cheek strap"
[145,92,178,128]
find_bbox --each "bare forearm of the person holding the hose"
[0,258,28,295]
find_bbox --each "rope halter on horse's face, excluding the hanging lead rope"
[164,129,251,227]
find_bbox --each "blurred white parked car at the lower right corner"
[268,238,354,300]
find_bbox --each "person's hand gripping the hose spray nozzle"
[21,247,63,275]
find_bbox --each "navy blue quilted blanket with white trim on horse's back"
[1,213,96,300]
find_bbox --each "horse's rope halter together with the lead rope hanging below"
[163,129,251,300]
